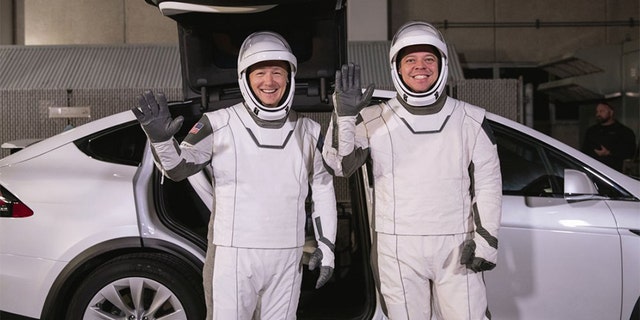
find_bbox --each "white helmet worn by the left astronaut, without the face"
[238,31,298,120]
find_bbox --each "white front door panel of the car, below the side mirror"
[485,196,622,319]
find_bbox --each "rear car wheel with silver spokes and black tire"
[66,253,206,319]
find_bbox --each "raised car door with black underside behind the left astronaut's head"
[146,0,347,111]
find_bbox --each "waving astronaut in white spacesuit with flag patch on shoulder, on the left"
[132,32,337,320]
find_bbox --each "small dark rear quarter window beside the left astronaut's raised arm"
[75,121,147,166]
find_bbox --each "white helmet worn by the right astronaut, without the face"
[389,21,449,106]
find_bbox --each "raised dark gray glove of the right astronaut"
[333,63,375,117]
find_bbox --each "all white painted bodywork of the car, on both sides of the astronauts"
[0,92,640,319]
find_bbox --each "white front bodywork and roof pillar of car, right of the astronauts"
[485,111,640,319]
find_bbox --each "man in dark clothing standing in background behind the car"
[582,102,636,172]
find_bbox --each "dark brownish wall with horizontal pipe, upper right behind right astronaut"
[390,0,640,63]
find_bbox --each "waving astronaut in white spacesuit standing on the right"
[323,21,502,320]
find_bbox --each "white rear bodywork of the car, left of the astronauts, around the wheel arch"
[0,112,204,318]
